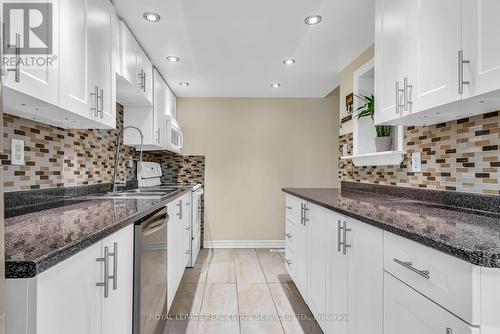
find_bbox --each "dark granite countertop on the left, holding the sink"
[5,188,190,278]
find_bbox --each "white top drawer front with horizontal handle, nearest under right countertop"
[384,232,480,325]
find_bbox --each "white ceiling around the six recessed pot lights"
[113,0,375,97]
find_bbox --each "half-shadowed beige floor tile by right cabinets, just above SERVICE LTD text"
[269,282,311,316]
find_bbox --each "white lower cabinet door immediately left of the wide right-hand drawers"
[346,218,384,334]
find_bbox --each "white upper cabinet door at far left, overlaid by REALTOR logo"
[3,0,59,106]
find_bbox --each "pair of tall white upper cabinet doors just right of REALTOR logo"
[59,0,116,128]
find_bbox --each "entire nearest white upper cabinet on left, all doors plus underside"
[4,0,116,129]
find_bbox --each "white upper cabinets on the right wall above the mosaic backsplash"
[375,0,500,125]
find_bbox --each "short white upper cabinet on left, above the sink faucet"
[116,21,153,106]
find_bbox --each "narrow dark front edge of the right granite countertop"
[281,188,500,268]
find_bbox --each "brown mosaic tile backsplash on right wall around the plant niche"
[339,111,500,195]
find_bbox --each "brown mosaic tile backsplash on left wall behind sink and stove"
[0,105,204,191]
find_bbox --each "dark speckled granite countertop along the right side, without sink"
[283,187,500,268]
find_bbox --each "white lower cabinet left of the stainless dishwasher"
[6,225,134,334]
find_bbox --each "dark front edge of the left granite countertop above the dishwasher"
[5,188,191,279]
